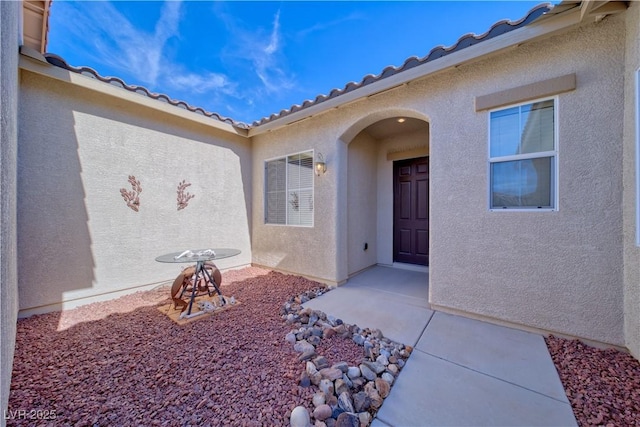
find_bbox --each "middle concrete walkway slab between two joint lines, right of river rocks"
[416,312,569,403]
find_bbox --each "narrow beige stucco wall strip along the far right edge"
[623,2,640,359]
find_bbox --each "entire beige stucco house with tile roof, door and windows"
[0,1,640,422]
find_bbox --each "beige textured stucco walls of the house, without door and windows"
[8,3,640,352]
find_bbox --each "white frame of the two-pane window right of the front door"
[486,95,560,212]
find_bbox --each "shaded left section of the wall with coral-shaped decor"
[17,77,95,318]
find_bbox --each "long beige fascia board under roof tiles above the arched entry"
[249,9,580,137]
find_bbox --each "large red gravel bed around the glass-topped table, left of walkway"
[7,267,363,426]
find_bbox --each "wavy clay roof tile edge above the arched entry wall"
[251,3,553,127]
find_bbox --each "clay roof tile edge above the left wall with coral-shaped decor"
[44,53,249,129]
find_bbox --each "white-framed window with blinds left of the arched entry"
[265,151,314,227]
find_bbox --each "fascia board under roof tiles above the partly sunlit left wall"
[19,52,247,137]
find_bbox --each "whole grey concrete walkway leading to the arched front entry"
[305,267,576,427]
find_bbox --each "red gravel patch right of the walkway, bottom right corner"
[546,336,640,427]
